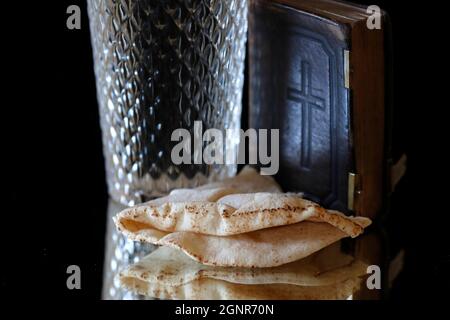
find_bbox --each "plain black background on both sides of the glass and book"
[1,0,450,299]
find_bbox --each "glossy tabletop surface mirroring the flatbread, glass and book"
[102,200,404,300]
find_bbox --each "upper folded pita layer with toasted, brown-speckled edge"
[115,189,370,243]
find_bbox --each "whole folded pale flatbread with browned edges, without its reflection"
[115,167,371,268]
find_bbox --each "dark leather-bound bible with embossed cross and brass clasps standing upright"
[249,0,404,218]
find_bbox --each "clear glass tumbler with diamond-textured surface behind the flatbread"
[88,0,247,205]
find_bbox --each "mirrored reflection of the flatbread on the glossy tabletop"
[120,246,367,300]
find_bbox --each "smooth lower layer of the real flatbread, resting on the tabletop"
[155,217,370,268]
